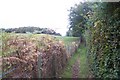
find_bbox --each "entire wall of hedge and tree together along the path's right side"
[67,2,120,79]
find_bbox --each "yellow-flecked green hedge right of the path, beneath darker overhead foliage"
[88,9,120,78]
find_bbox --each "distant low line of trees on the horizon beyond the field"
[1,26,61,36]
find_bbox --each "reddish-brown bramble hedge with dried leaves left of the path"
[2,33,67,78]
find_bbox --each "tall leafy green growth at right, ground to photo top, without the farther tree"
[88,3,120,78]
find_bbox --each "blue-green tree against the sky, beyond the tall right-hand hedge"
[69,3,91,37]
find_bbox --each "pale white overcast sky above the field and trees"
[0,0,82,36]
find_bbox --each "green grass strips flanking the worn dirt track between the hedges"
[61,45,89,78]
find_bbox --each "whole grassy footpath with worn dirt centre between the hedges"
[61,45,91,78]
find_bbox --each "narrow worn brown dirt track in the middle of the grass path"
[72,57,80,78]
